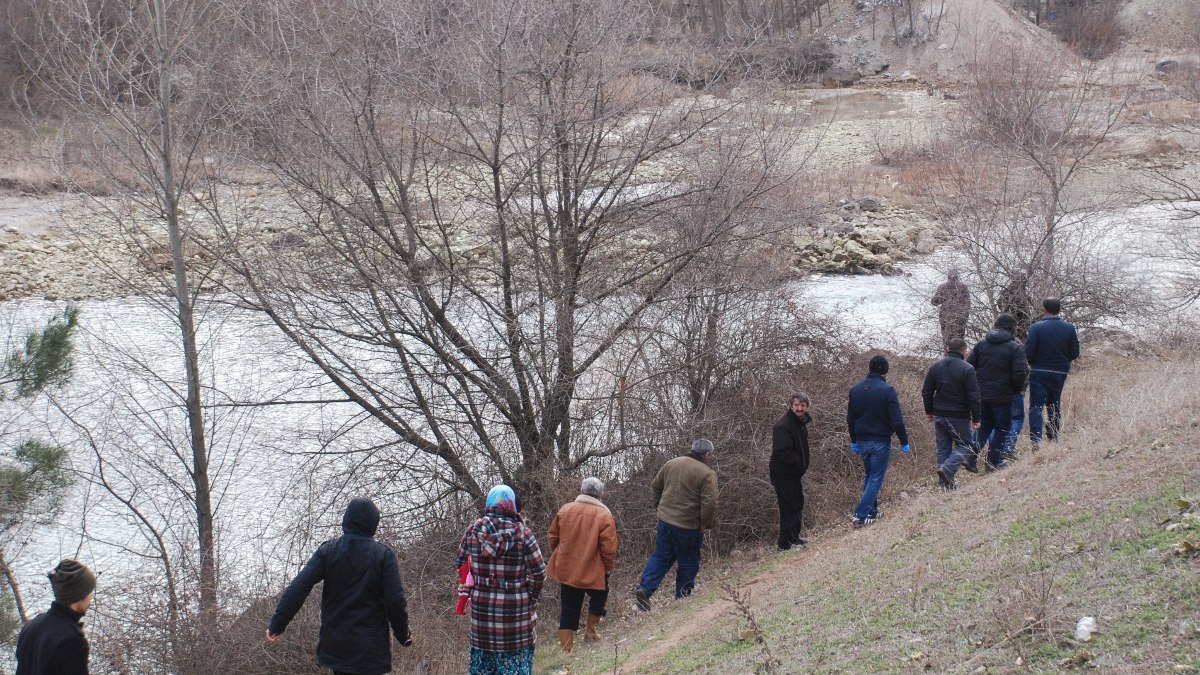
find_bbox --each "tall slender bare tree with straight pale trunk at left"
[24,0,262,611]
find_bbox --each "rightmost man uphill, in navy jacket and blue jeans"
[1025,298,1079,449]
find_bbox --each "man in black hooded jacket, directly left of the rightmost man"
[967,313,1030,471]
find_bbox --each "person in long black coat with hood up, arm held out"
[269,497,409,675]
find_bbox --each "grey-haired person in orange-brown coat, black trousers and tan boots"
[546,478,617,652]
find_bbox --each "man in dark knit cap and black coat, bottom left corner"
[17,560,96,675]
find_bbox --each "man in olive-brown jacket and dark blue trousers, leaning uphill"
[636,438,718,610]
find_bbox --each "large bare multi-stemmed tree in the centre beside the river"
[213,0,788,508]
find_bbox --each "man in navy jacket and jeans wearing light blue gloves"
[846,356,908,527]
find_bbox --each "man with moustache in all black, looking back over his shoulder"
[770,393,812,551]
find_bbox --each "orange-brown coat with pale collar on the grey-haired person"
[546,495,617,591]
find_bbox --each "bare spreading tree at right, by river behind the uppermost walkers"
[929,41,1139,325]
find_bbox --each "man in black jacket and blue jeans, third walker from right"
[920,338,980,490]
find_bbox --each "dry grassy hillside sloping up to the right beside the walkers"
[539,359,1200,674]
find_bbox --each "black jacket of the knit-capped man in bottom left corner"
[17,602,88,675]
